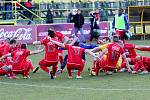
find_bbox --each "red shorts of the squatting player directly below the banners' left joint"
[39,59,58,67]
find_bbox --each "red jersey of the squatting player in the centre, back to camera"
[65,44,85,64]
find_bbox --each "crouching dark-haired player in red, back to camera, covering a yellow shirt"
[92,36,130,76]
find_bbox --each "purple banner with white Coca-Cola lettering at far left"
[0,25,37,44]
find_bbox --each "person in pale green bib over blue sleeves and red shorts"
[112,8,129,42]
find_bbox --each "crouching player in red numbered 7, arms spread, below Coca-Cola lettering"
[0,44,43,78]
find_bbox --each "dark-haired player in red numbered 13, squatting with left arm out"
[33,31,61,78]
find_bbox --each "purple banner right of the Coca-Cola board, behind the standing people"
[37,22,109,40]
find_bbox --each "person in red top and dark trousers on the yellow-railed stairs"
[24,0,33,25]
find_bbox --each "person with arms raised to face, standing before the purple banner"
[90,9,100,42]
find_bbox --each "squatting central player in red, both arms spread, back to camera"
[50,39,95,78]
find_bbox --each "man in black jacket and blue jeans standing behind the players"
[73,9,86,43]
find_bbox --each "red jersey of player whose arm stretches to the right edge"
[124,43,136,58]
